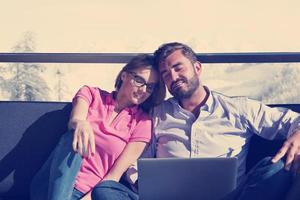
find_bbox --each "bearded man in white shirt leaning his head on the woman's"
[94,43,300,199]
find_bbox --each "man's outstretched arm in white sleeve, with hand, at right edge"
[243,99,300,171]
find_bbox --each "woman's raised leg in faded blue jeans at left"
[30,131,82,200]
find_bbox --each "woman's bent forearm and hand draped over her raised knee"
[68,97,95,157]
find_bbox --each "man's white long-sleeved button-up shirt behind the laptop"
[128,88,300,183]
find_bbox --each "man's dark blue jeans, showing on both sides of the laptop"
[92,157,292,200]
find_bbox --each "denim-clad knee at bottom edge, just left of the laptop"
[92,181,138,200]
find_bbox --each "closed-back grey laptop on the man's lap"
[138,158,237,200]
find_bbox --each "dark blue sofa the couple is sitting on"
[0,101,300,200]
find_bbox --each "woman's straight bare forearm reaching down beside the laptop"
[103,142,147,182]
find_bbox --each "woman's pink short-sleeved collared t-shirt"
[73,86,151,193]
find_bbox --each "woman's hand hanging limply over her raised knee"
[72,120,95,157]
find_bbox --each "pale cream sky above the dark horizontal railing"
[0,0,300,52]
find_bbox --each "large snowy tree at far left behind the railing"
[6,32,50,101]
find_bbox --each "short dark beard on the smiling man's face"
[169,74,200,100]
